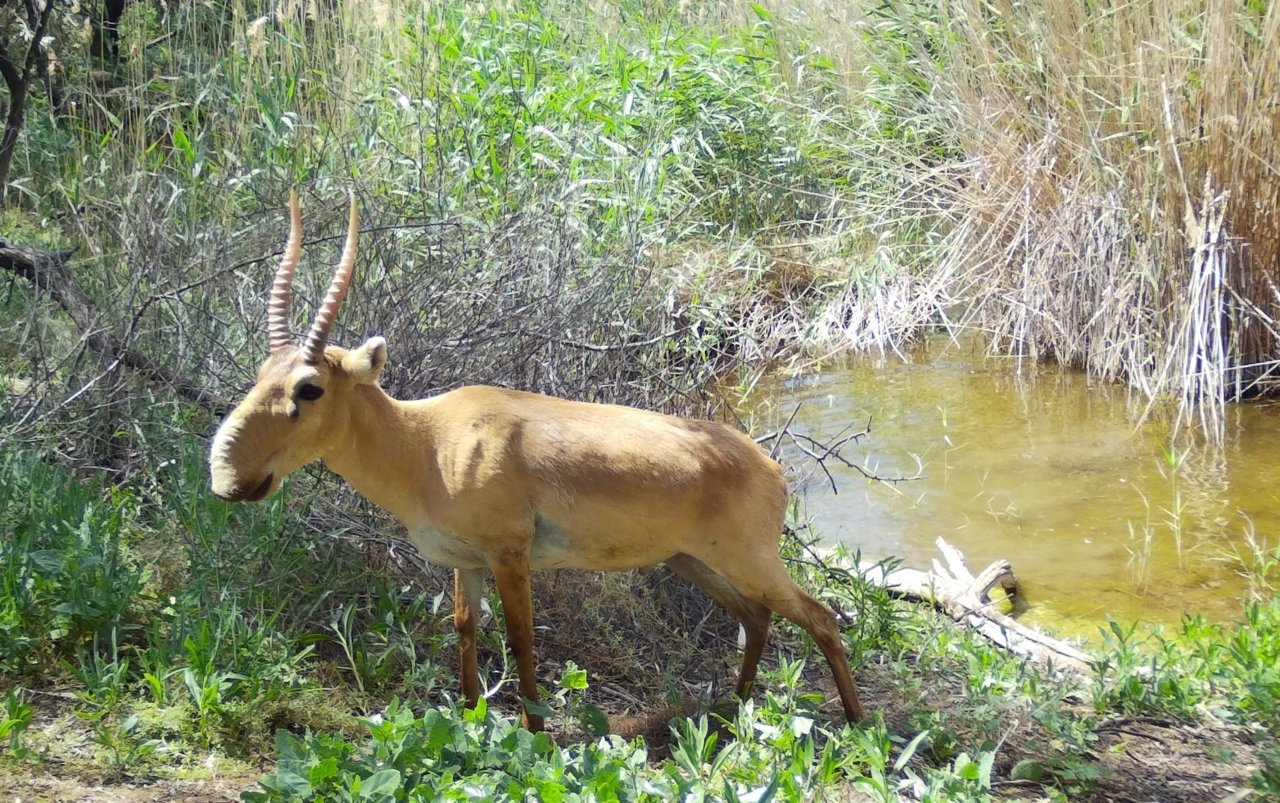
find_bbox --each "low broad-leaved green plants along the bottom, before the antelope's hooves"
[244,662,993,803]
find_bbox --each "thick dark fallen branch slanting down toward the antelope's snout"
[0,241,218,407]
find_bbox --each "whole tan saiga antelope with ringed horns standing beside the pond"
[209,192,861,730]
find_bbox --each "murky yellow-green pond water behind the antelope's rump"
[753,341,1280,637]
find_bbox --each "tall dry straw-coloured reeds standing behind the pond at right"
[899,0,1280,433]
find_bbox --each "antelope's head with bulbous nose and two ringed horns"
[209,192,387,502]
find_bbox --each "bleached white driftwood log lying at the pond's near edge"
[865,538,1093,672]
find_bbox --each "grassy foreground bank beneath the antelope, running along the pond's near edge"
[0,445,1280,800]
